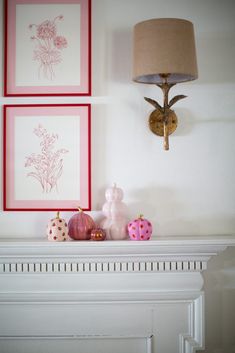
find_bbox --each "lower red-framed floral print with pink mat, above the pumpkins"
[3,104,91,211]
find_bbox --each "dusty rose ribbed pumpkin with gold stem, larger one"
[68,207,96,240]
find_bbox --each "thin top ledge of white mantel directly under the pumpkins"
[0,235,235,253]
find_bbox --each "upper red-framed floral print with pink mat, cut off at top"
[4,0,91,97]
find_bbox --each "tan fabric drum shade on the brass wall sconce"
[133,18,198,84]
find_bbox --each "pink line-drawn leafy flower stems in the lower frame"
[24,124,69,193]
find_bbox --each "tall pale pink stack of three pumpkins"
[100,184,127,240]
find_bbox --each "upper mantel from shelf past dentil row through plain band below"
[0,235,235,302]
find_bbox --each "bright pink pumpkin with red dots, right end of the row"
[127,215,152,240]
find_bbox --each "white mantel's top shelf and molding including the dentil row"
[0,235,235,274]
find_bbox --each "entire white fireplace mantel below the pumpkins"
[0,235,235,353]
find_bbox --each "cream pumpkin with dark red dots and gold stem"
[47,212,68,241]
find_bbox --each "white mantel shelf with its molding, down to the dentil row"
[0,235,235,263]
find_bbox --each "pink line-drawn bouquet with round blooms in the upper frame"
[29,15,68,80]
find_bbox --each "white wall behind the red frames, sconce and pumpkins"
[0,0,235,353]
